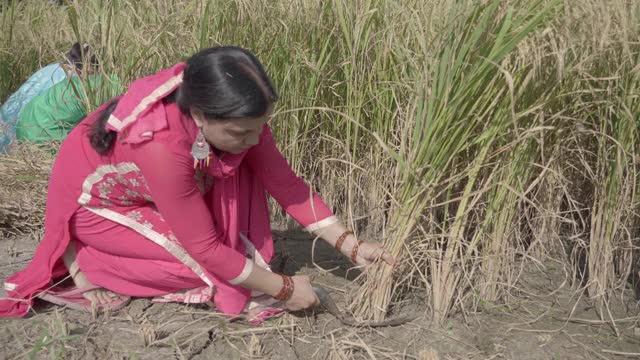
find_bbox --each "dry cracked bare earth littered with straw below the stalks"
[0,230,640,360]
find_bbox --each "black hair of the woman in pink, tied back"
[90,46,278,154]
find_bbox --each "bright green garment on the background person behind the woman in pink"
[16,74,120,143]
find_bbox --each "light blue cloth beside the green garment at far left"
[0,63,67,153]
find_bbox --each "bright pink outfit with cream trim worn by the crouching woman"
[0,63,337,316]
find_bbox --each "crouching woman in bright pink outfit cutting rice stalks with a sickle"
[0,47,395,316]
